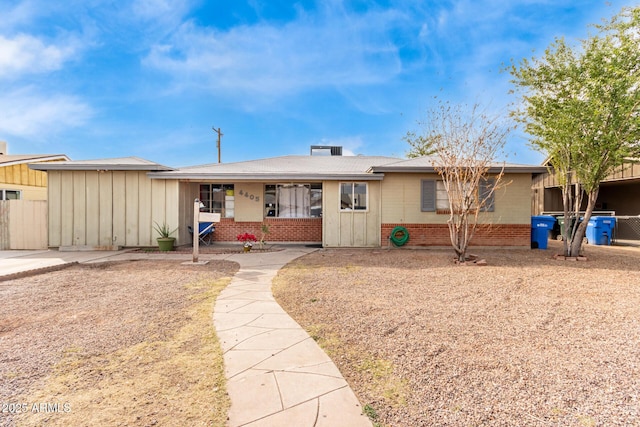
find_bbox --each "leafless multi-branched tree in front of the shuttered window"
[421,102,512,262]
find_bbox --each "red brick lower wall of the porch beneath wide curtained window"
[213,218,322,243]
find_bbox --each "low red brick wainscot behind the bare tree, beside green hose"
[380,224,531,246]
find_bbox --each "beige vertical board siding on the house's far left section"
[49,171,180,247]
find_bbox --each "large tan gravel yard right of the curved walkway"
[274,242,640,427]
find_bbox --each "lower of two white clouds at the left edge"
[0,88,93,140]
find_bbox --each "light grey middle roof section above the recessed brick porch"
[149,156,400,181]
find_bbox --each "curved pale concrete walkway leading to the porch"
[213,247,371,427]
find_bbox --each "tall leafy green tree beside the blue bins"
[510,7,640,256]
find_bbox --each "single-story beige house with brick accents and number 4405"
[31,150,545,247]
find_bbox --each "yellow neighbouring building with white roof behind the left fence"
[0,142,69,200]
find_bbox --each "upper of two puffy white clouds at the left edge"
[0,34,76,78]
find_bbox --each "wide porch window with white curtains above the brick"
[264,183,322,218]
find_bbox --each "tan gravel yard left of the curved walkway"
[0,261,238,425]
